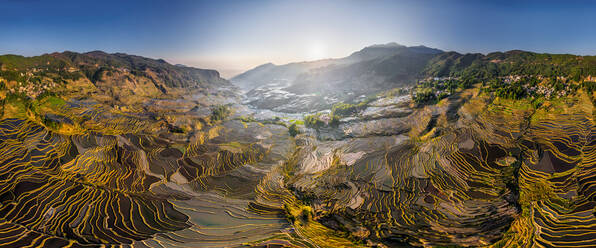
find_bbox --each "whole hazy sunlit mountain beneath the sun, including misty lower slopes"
[231,43,443,112]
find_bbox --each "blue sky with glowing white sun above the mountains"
[0,0,596,78]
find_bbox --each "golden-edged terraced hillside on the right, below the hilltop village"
[289,86,596,247]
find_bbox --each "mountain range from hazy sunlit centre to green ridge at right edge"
[231,43,596,113]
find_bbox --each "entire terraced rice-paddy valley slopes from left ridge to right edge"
[0,49,596,247]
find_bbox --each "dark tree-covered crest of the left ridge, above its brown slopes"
[0,51,229,88]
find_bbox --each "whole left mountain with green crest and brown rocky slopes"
[0,51,233,107]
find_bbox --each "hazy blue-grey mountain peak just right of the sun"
[288,44,442,96]
